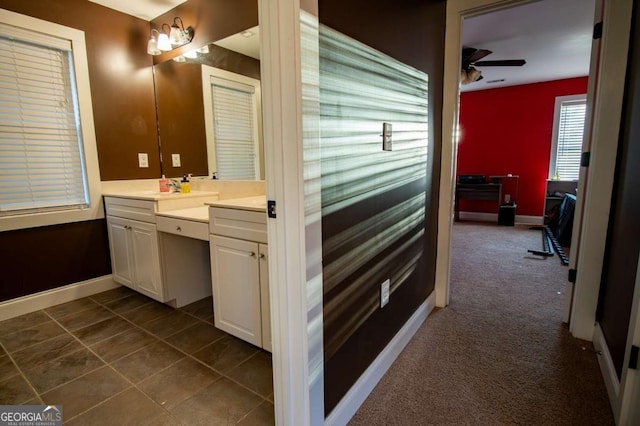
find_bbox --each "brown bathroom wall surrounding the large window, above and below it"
[0,0,160,300]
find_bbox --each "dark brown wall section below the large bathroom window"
[0,219,111,302]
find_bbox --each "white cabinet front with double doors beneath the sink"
[105,197,165,302]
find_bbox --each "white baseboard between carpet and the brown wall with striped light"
[325,291,435,426]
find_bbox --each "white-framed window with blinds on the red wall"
[549,95,587,180]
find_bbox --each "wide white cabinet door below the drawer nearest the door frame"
[210,235,262,346]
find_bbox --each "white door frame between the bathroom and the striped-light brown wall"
[258,0,324,425]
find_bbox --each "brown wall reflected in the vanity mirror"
[154,45,260,177]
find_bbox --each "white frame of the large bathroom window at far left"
[0,9,104,232]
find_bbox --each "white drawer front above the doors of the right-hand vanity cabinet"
[209,207,267,244]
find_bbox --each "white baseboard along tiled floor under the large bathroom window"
[0,275,120,321]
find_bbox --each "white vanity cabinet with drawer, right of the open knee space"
[209,200,271,351]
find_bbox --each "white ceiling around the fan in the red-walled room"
[461,0,595,92]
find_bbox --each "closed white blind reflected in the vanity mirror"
[211,79,257,180]
